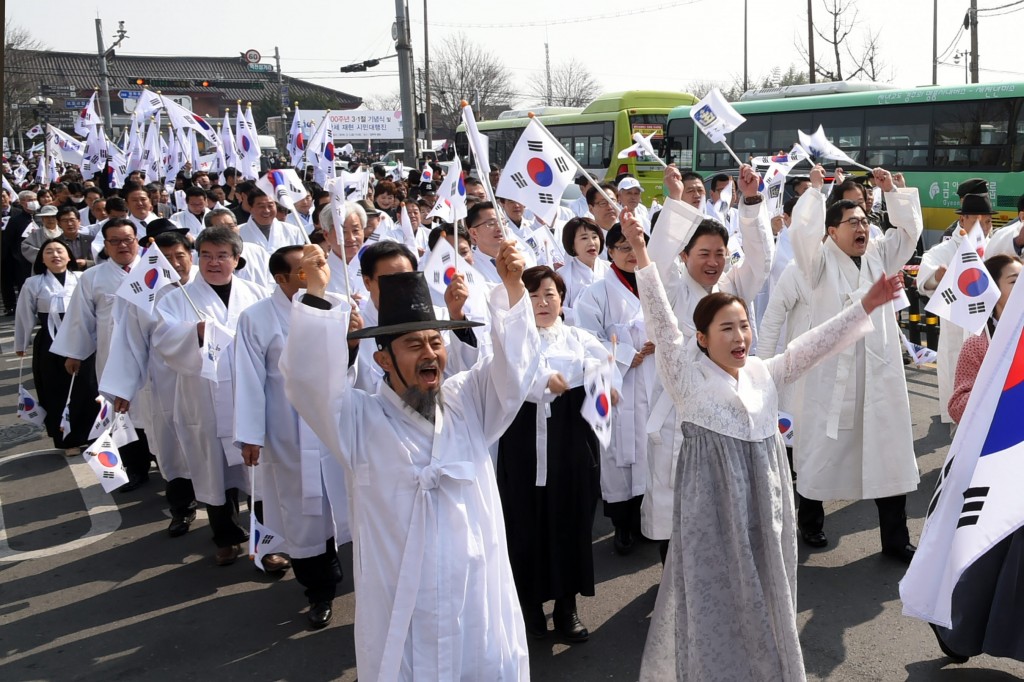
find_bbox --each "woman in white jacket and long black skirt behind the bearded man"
[496,265,621,642]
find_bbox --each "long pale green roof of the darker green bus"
[669,83,1024,120]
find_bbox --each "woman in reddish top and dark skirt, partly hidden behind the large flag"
[932,254,1024,663]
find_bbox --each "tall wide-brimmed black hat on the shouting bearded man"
[348,271,483,339]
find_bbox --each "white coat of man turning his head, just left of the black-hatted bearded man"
[234,288,352,559]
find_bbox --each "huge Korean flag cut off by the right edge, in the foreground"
[900,278,1024,628]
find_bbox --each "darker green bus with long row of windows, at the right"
[660,83,1024,245]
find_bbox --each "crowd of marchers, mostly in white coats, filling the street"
[2,146,1024,680]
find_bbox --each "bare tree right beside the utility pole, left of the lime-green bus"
[430,33,515,137]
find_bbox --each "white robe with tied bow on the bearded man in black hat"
[281,288,539,682]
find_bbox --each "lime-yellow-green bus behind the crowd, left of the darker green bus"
[455,90,697,199]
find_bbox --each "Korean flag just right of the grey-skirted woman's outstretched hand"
[925,229,999,334]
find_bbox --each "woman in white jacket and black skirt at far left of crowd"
[14,239,99,457]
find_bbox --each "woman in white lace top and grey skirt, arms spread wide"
[623,209,901,682]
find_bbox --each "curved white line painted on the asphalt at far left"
[0,450,121,561]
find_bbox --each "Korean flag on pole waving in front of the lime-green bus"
[496,119,575,225]
